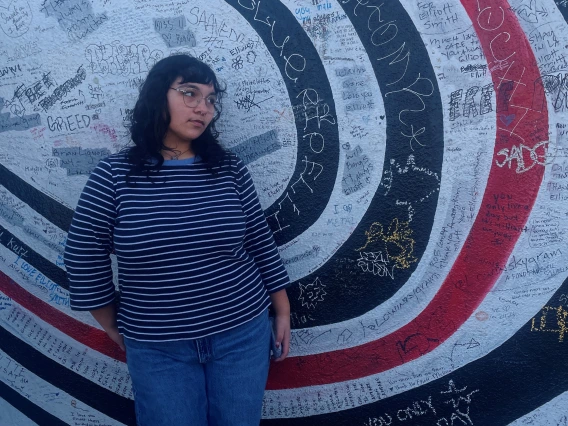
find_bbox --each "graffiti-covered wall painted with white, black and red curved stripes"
[0,0,568,426]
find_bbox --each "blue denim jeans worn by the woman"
[124,311,270,426]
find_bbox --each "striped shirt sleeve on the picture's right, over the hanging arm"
[236,159,290,294]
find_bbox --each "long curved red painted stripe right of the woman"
[268,0,548,389]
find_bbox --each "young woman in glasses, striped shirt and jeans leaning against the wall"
[65,55,290,426]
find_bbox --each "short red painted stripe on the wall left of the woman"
[0,272,126,362]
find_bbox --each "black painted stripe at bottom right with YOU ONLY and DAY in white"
[261,279,568,426]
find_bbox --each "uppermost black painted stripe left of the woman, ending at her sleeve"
[0,164,73,232]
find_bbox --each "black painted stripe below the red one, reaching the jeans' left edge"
[0,328,136,425]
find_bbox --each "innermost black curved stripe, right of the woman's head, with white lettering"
[225,0,339,246]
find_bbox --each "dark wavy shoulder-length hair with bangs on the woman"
[126,54,226,176]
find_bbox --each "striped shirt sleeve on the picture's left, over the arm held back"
[64,160,116,311]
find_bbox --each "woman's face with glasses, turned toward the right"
[166,77,216,145]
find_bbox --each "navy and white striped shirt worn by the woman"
[65,154,289,341]
